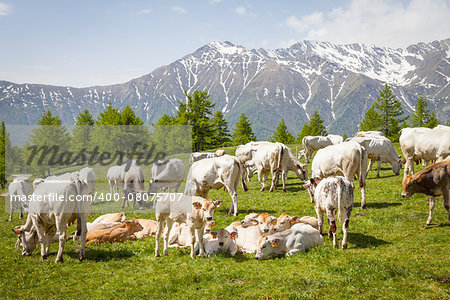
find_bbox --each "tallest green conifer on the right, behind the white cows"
[375,84,406,140]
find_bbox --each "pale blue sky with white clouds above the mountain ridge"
[0,0,450,87]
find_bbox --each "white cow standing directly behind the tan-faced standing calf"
[185,154,248,216]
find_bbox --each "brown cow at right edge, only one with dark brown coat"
[402,157,450,226]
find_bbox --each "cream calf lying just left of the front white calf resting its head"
[226,213,277,253]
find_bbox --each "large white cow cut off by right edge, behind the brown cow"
[399,127,450,177]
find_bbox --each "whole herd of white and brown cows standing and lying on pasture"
[9,125,450,262]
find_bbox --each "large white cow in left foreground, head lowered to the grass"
[13,173,89,263]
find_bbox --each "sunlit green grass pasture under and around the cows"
[0,144,450,299]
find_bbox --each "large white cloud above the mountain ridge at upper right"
[285,0,450,47]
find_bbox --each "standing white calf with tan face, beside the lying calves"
[155,196,222,258]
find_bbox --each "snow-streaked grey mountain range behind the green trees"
[0,39,450,139]
